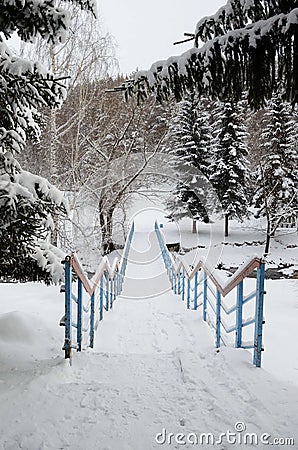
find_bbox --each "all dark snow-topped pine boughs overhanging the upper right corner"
[122,0,298,108]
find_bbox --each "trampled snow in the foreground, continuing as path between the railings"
[0,219,298,450]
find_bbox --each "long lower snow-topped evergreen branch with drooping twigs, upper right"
[120,8,298,108]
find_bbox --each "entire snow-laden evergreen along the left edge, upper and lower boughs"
[0,0,94,283]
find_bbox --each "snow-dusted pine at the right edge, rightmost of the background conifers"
[253,93,298,254]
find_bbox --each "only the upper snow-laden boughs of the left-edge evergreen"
[0,0,96,153]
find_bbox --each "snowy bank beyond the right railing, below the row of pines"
[164,219,298,274]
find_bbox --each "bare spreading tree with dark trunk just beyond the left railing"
[70,87,167,254]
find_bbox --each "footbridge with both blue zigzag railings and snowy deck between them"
[61,222,265,367]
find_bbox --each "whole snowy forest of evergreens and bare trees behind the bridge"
[0,0,298,283]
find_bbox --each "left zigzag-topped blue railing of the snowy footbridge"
[60,224,134,359]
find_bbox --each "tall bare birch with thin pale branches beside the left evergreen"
[22,7,117,243]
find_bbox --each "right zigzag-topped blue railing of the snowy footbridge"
[155,222,265,367]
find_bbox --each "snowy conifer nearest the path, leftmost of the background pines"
[167,92,212,232]
